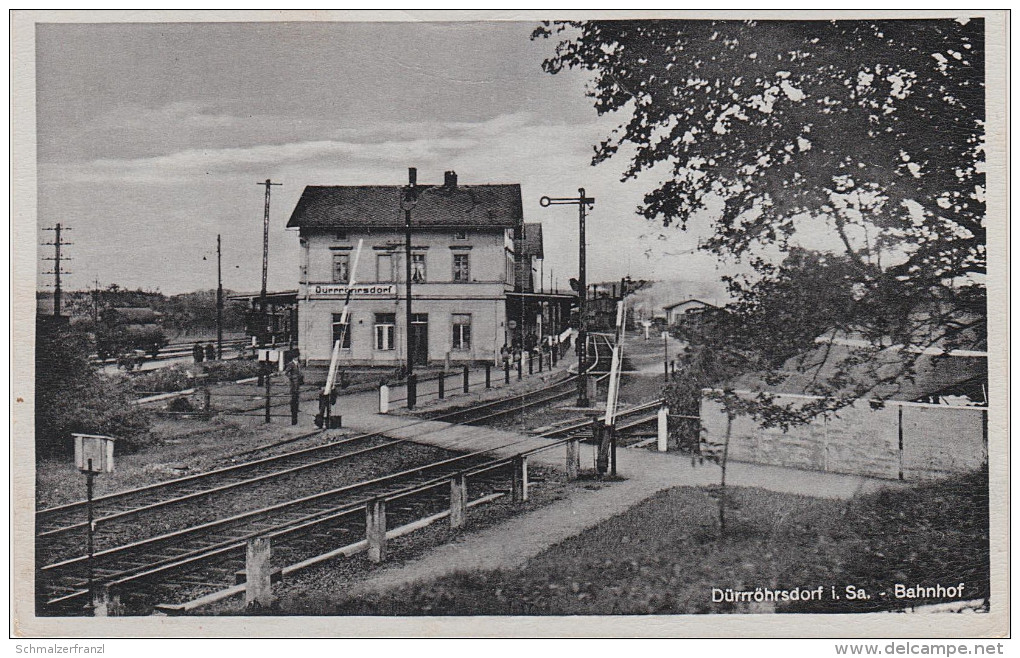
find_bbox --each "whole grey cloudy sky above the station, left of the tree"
[36,21,734,294]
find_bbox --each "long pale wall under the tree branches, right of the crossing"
[701,396,987,479]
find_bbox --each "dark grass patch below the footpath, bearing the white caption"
[297,465,988,615]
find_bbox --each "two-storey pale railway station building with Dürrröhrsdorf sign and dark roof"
[287,171,573,366]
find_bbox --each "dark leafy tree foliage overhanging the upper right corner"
[532,19,986,418]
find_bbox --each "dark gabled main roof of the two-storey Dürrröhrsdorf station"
[287,184,524,229]
